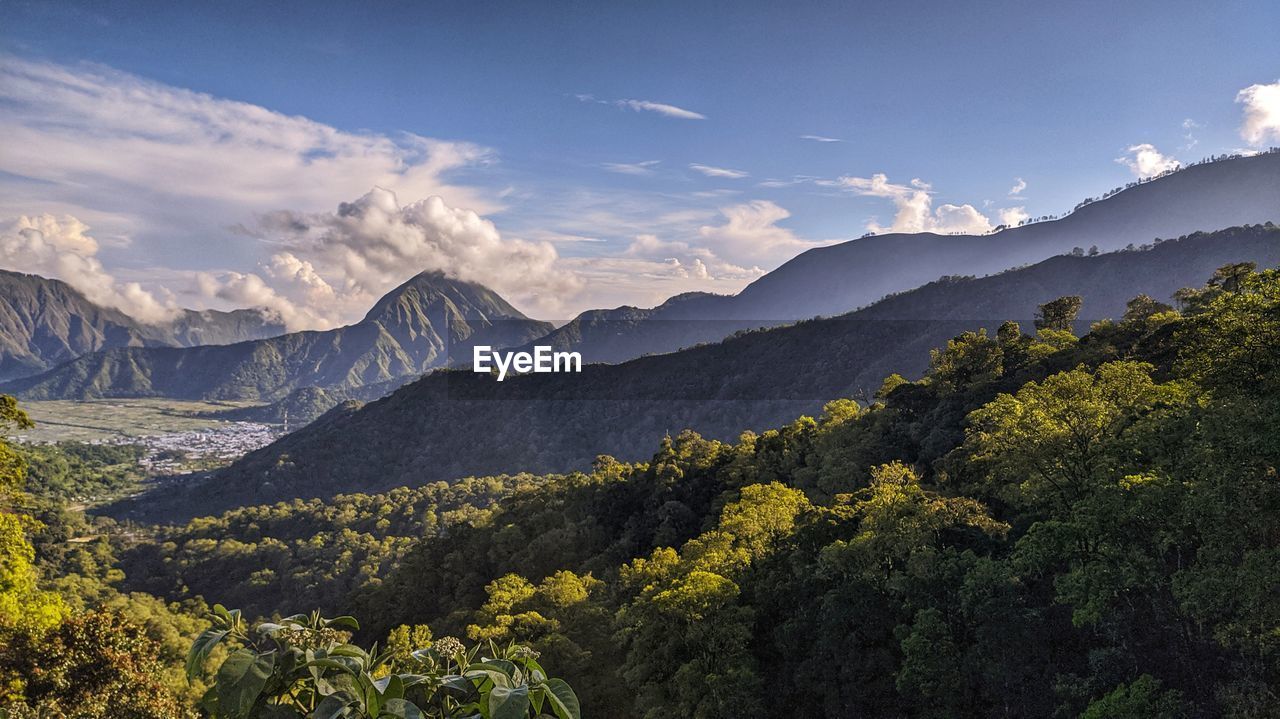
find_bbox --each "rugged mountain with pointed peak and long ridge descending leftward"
[0,273,552,400]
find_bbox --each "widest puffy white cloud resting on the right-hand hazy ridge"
[834,173,992,234]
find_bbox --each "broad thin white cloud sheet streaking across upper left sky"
[0,56,500,280]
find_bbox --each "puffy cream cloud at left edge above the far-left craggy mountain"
[0,215,177,322]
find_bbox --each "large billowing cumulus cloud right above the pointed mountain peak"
[232,188,582,324]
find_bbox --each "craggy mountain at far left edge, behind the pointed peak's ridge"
[0,270,284,381]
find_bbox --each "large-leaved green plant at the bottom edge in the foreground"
[187,605,581,719]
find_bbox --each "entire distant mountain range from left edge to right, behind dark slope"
[0,152,1280,409]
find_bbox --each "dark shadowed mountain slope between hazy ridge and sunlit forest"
[116,225,1280,518]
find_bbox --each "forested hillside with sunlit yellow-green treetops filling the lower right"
[10,265,1280,719]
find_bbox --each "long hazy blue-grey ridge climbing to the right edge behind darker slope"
[519,152,1280,362]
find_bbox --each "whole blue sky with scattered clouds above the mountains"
[0,1,1280,326]
